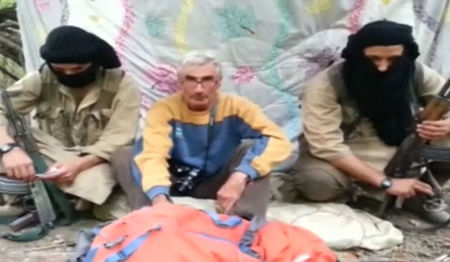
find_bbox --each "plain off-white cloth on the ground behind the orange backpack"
[173,197,403,250]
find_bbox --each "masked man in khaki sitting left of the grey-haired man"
[0,26,139,213]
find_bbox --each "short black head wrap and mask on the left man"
[40,26,121,88]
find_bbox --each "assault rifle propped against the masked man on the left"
[1,90,57,228]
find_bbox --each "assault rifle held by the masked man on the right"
[378,79,450,216]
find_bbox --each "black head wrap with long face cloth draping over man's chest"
[342,20,419,146]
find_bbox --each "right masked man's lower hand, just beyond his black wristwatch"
[386,178,433,198]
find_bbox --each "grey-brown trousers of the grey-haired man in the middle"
[112,145,270,217]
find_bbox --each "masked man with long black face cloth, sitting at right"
[281,20,450,222]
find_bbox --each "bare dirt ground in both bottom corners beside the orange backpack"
[0,184,450,262]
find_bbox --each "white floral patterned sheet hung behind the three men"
[18,0,450,170]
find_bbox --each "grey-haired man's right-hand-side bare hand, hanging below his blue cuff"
[217,172,248,213]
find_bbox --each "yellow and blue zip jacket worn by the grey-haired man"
[135,94,292,199]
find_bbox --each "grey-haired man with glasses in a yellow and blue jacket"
[115,52,292,217]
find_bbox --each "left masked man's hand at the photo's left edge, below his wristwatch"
[2,147,35,181]
